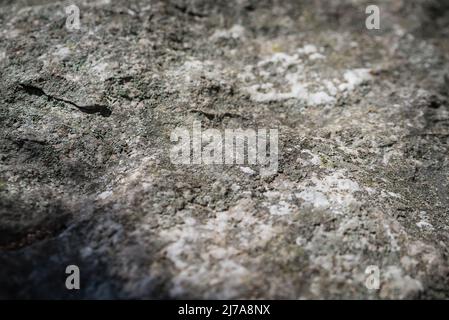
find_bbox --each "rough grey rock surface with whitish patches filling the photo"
[0,0,449,299]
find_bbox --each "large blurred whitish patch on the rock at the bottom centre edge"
[158,199,276,298]
